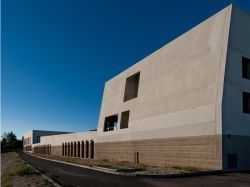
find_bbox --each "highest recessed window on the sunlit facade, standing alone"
[123,72,140,102]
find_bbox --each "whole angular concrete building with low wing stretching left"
[25,5,250,170]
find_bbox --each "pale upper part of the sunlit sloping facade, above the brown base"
[97,6,232,142]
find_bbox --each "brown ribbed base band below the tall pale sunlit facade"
[95,135,222,169]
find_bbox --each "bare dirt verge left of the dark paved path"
[1,152,53,187]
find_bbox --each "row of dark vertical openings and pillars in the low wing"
[62,140,94,159]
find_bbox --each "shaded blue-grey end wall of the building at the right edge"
[222,7,250,169]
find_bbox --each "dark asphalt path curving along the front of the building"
[20,153,250,187]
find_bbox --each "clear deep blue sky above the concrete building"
[1,0,250,138]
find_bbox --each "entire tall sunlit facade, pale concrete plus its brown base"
[93,6,232,169]
